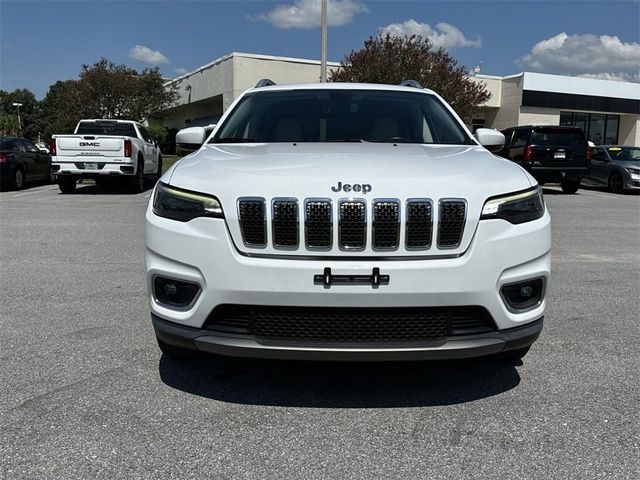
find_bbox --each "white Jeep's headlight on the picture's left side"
[153,182,224,222]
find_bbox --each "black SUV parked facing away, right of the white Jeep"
[498,125,591,193]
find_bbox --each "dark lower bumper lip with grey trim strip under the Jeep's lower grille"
[151,314,544,361]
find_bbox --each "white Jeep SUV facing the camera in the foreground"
[146,81,551,360]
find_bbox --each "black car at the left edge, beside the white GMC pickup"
[0,137,52,190]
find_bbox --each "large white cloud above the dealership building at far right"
[516,32,640,82]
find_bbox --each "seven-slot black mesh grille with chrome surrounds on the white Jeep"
[238,197,467,251]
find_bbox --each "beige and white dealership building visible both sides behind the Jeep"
[163,52,640,145]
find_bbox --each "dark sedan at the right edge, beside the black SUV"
[588,145,640,193]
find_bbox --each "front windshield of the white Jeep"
[210,89,475,145]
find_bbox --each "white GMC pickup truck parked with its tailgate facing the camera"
[49,120,162,193]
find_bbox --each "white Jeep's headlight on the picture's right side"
[480,187,544,224]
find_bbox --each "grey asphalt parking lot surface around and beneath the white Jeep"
[0,185,640,479]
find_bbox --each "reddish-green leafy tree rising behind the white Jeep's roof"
[329,32,491,122]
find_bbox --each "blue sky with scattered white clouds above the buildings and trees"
[0,0,640,98]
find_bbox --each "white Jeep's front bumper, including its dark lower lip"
[146,202,551,360]
